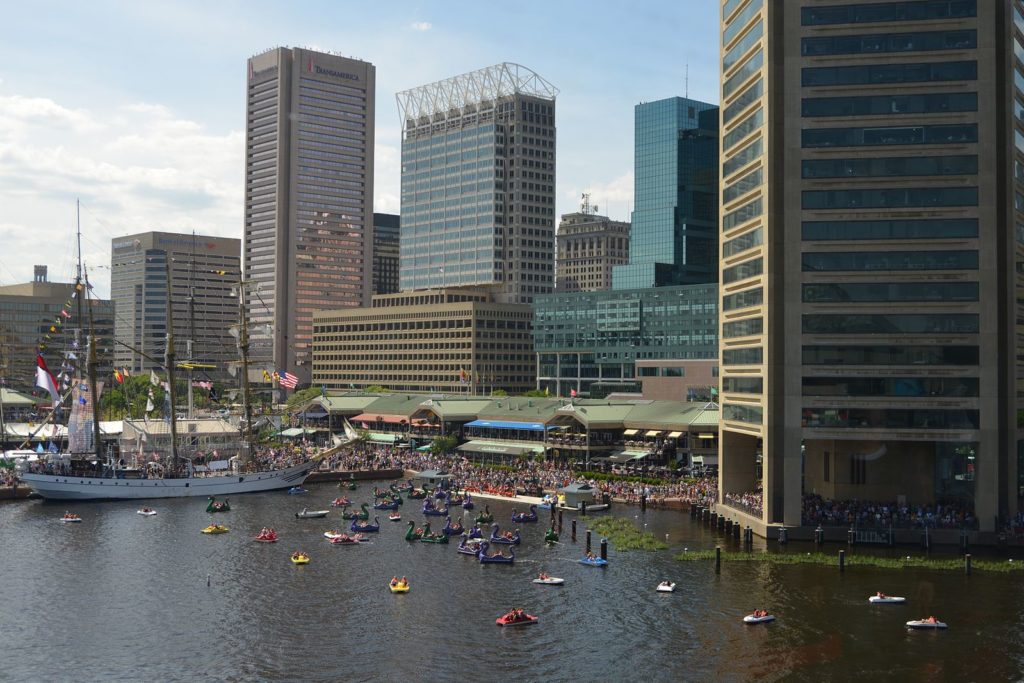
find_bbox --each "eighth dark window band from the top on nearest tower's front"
[801,218,978,241]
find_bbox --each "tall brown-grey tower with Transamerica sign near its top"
[245,47,375,383]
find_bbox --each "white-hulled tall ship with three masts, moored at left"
[22,210,349,501]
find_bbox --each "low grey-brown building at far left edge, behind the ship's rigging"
[0,265,114,395]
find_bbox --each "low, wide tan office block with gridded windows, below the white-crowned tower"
[313,288,534,395]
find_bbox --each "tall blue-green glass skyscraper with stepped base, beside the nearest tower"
[612,97,718,290]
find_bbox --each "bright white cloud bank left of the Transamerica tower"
[0,90,245,296]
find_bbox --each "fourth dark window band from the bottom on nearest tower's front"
[802,313,979,335]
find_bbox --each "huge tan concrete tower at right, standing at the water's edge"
[720,0,1024,535]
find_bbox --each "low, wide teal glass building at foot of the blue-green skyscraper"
[534,284,718,400]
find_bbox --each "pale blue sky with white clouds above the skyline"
[0,0,719,297]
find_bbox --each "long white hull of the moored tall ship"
[22,461,318,501]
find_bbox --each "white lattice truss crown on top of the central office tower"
[395,61,558,127]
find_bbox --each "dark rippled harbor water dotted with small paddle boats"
[0,484,1024,681]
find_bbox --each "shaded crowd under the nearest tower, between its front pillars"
[801,495,978,528]
